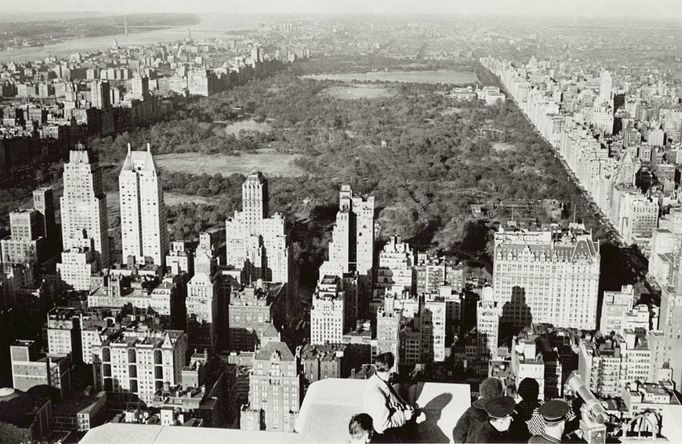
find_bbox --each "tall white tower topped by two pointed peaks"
[118,144,168,267]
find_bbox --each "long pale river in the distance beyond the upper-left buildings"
[0,14,260,62]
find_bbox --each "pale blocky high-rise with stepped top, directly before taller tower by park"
[310,276,344,344]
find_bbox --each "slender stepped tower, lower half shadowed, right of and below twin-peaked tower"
[185,233,219,354]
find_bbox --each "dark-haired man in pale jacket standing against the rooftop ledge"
[362,353,420,442]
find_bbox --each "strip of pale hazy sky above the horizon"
[0,0,682,18]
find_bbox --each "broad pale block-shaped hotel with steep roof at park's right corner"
[493,225,600,330]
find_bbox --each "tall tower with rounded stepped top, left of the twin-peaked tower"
[60,144,109,267]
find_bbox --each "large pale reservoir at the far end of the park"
[303,69,478,85]
